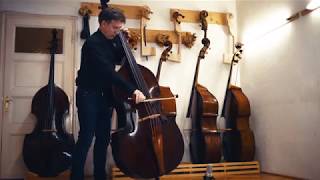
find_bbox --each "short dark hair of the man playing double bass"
[98,7,126,24]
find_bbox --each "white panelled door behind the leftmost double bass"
[0,12,75,178]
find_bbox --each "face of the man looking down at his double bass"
[100,20,124,39]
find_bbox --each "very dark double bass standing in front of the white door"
[23,29,74,177]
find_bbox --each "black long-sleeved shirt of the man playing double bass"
[76,30,135,102]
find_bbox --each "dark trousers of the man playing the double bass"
[71,87,112,180]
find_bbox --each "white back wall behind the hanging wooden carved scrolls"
[0,0,239,177]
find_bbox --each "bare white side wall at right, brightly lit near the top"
[237,0,320,179]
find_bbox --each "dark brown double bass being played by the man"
[111,32,184,178]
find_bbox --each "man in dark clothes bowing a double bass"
[71,8,145,180]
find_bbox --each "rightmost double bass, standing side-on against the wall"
[221,43,255,162]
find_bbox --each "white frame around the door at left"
[0,11,79,179]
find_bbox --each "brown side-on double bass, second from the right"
[187,11,221,163]
